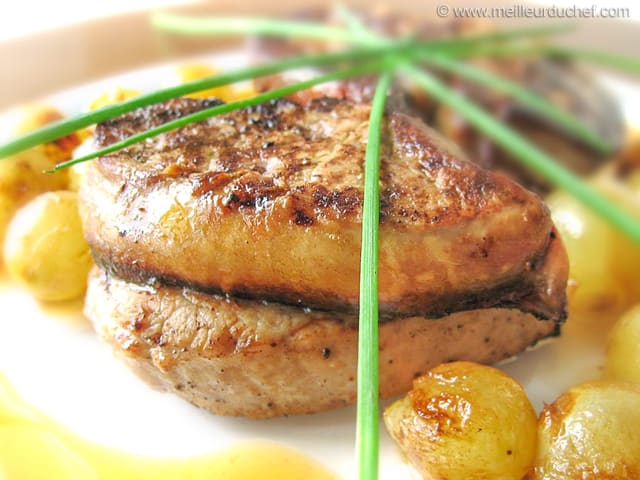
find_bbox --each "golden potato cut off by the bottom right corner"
[535,381,640,480]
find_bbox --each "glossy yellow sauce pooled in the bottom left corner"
[0,374,337,480]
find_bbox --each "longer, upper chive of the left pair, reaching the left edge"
[0,42,415,159]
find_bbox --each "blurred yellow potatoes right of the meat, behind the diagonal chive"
[547,142,640,312]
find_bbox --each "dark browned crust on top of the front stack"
[95,98,546,228]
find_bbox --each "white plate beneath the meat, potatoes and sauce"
[0,55,640,479]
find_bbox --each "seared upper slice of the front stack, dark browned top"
[80,99,567,320]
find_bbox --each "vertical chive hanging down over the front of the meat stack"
[356,70,392,480]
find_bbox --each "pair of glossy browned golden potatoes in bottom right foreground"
[384,351,640,480]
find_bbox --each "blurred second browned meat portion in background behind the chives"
[250,8,626,192]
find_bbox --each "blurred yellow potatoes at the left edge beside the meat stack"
[0,106,92,301]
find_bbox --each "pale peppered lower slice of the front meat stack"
[85,269,558,418]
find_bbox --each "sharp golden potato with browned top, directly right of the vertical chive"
[384,362,536,480]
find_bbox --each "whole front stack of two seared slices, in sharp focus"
[80,98,568,418]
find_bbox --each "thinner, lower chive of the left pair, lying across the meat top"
[49,60,396,173]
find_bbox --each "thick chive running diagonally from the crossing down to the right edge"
[401,65,640,243]
